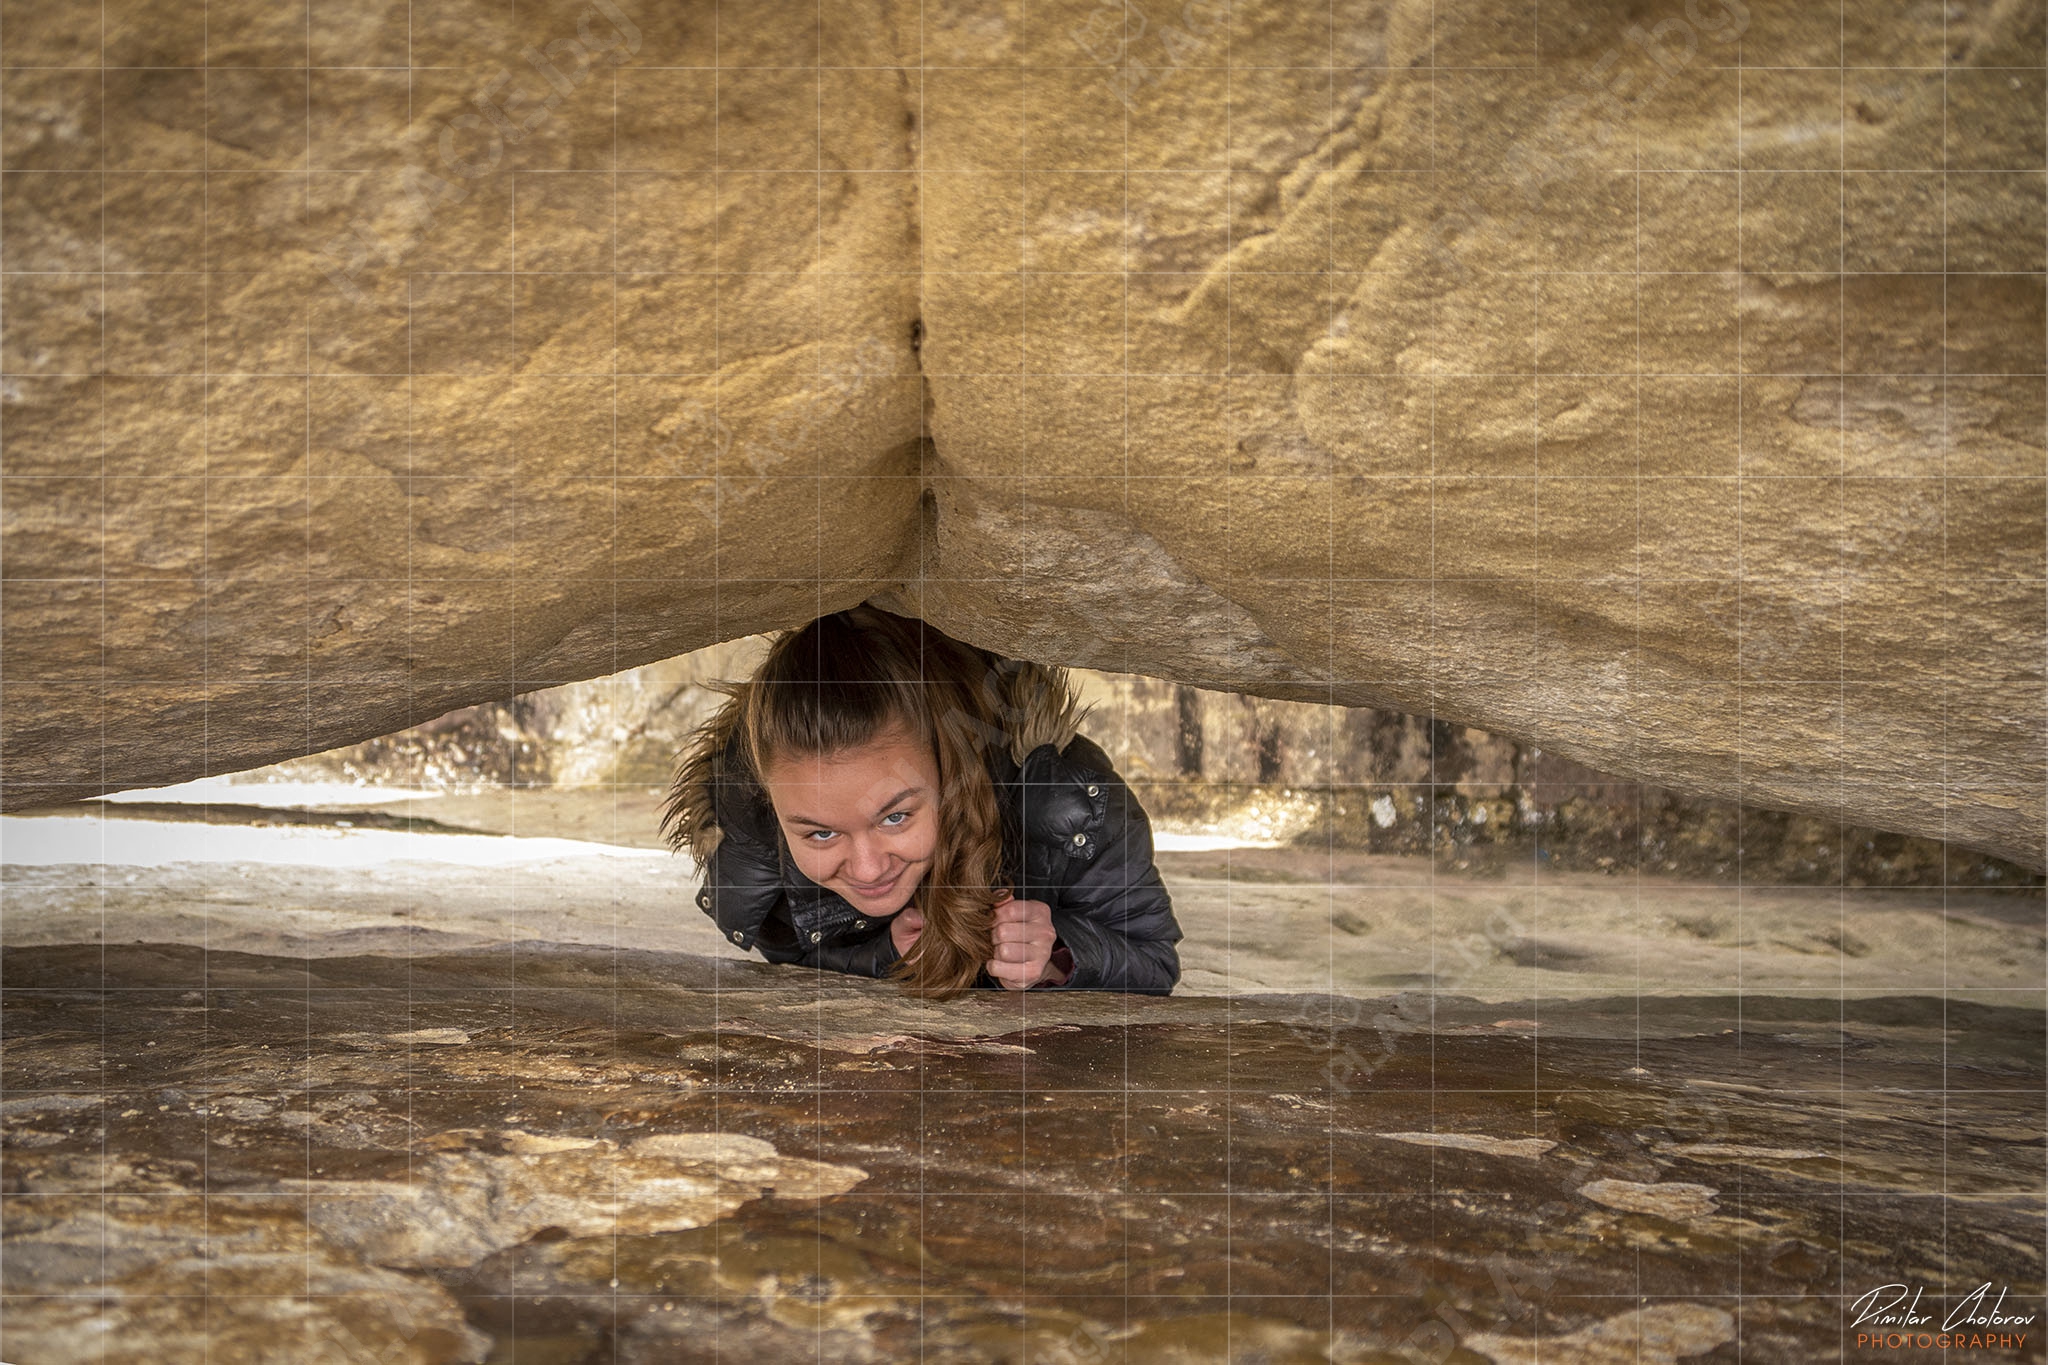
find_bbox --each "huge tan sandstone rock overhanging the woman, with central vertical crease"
[0,0,2048,866]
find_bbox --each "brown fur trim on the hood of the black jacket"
[662,659,1087,866]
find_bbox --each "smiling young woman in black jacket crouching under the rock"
[662,606,1180,999]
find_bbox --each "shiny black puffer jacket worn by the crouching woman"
[696,735,1180,995]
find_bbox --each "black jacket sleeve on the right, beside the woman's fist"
[1042,774,1180,995]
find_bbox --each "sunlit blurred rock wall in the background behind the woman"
[240,636,2042,886]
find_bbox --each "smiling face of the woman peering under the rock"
[762,724,938,919]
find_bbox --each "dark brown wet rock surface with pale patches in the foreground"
[0,943,2048,1361]
